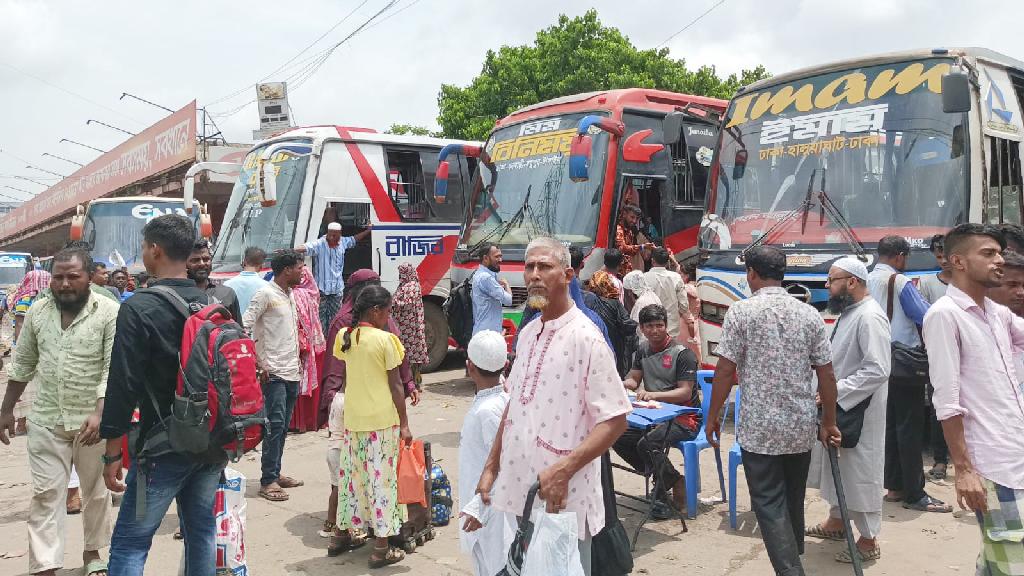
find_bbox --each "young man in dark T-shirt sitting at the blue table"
[613,304,700,520]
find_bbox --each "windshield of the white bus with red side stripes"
[213,140,312,273]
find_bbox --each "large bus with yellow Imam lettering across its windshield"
[697,48,1024,367]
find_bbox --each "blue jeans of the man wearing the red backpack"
[108,453,226,576]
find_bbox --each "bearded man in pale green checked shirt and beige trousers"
[0,248,118,576]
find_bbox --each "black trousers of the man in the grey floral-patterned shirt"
[742,450,811,576]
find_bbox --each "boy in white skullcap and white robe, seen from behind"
[459,330,515,576]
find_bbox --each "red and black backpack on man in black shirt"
[148,285,268,461]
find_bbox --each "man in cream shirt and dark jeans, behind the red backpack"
[242,250,305,502]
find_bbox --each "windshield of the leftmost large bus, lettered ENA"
[82,198,199,274]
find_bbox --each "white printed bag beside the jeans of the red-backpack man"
[213,468,249,576]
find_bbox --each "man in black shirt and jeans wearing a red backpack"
[99,214,227,576]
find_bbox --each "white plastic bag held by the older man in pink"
[521,504,584,576]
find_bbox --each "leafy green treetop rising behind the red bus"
[437,10,769,139]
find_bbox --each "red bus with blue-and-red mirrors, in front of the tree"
[442,88,726,324]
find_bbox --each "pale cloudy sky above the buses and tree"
[0,0,1024,200]
